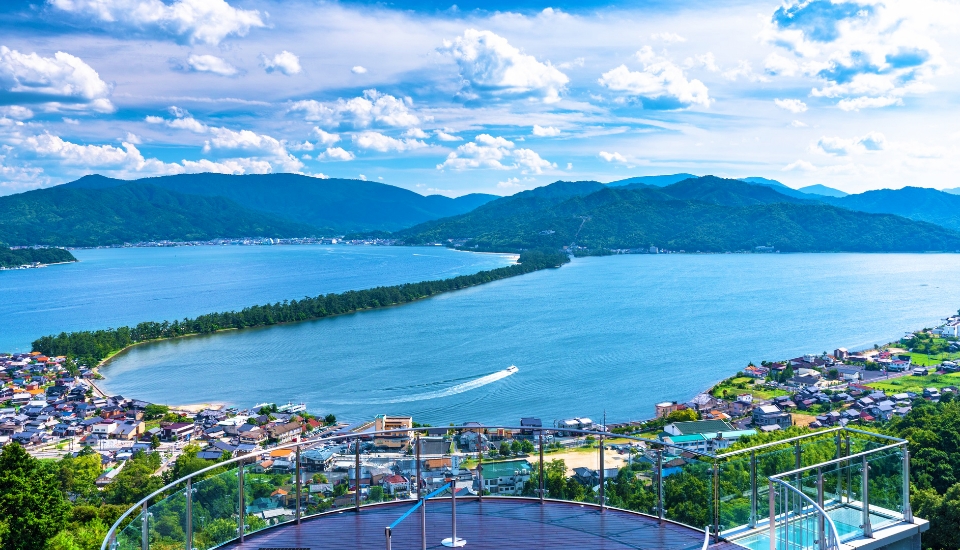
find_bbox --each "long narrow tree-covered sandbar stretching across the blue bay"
[33,250,569,364]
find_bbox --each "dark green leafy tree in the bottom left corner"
[0,443,70,550]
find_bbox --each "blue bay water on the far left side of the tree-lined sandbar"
[0,245,512,352]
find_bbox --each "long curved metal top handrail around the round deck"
[100,425,715,550]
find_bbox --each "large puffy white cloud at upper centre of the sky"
[439,29,570,103]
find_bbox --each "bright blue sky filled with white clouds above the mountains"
[0,0,960,196]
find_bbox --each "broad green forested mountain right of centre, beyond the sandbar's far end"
[397,177,960,252]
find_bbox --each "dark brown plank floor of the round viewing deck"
[224,498,741,550]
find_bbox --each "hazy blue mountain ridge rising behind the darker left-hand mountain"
[61,174,498,232]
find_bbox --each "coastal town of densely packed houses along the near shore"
[0,316,960,523]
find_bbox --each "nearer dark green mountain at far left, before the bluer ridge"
[0,183,317,246]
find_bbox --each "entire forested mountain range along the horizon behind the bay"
[0,174,960,250]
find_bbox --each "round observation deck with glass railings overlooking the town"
[101,425,929,550]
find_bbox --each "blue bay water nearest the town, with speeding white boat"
[97,254,960,424]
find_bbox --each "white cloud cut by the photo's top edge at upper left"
[49,0,266,45]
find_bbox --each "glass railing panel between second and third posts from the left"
[190,468,240,550]
